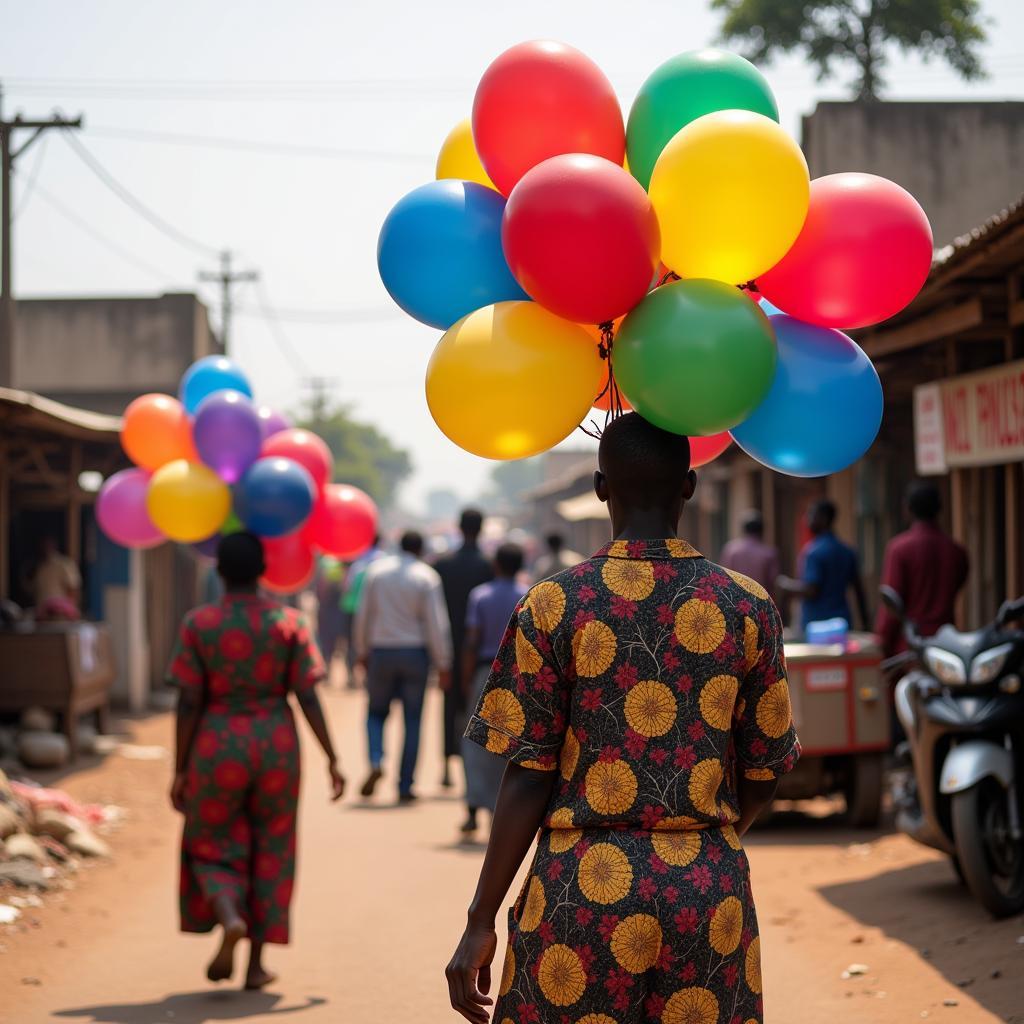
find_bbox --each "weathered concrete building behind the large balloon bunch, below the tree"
[802,101,1024,247]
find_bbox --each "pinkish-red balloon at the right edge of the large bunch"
[758,173,932,330]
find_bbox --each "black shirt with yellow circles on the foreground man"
[466,540,800,829]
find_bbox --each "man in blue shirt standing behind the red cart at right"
[778,500,870,631]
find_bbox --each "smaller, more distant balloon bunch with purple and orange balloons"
[96,355,377,593]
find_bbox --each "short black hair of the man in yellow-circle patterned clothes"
[597,413,690,507]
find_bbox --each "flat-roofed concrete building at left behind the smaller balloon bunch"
[13,294,219,416]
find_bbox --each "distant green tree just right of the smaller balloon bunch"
[299,404,413,508]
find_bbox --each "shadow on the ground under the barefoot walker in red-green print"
[53,989,327,1024]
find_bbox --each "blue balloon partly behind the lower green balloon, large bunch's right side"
[731,314,883,476]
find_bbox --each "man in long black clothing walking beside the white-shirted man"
[436,509,495,787]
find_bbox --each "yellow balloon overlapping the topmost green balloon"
[649,111,810,285]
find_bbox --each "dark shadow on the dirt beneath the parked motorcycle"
[819,860,1024,1024]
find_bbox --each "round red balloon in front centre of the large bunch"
[502,153,662,324]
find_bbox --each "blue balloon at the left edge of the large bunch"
[377,179,529,331]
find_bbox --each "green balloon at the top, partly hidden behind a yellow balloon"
[626,48,778,188]
